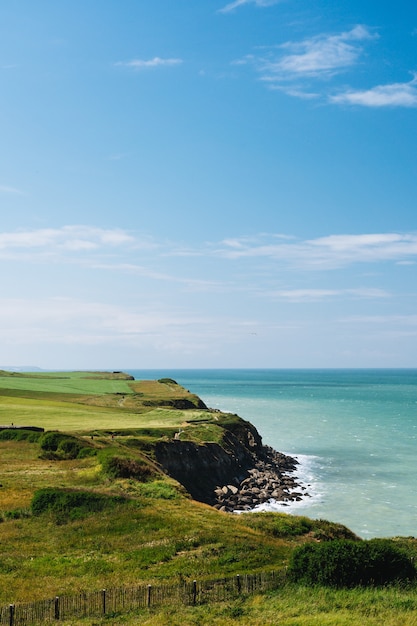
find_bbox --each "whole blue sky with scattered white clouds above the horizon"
[0,0,417,370]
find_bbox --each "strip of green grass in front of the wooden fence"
[35,586,417,626]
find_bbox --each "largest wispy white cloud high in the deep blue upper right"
[260,25,376,82]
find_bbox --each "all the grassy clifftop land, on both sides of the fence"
[0,373,417,626]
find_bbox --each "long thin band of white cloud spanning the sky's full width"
[0,225,417,270]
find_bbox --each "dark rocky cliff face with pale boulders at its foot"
[155,420,308,511]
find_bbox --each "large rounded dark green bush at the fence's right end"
[288,539,416,587]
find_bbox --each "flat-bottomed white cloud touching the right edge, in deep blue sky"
[330,75,417,108]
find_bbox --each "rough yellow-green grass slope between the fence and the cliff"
[0,436,358,603]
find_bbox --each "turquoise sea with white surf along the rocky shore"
[129,369,417,539]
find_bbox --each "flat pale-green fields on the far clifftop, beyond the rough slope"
[0,371,208,431]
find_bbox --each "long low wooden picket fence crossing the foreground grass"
[0,572,285,626]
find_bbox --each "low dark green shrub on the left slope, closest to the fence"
[31,487,127,520]
